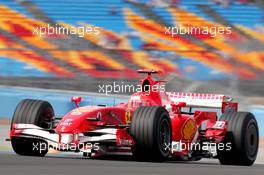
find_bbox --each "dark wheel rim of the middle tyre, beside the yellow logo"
[159,119,171,152]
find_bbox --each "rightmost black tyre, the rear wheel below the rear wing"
[217,112,259,166]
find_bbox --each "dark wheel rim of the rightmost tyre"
[246,123,258,157]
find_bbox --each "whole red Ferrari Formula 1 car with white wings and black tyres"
[10,70,259,165]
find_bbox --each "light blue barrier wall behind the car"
[0,86,264,136]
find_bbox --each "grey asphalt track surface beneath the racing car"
[0,152,264,175]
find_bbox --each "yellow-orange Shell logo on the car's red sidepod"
[182,119,196,140]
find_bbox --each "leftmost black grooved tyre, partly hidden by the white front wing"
[11,99,54,156]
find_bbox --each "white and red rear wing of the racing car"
[166,92,238,112]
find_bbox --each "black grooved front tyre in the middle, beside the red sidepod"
[130,106,172,161]
